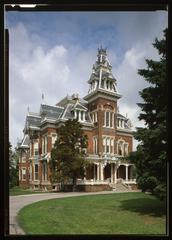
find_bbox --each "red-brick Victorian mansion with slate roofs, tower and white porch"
[18,48,136,191]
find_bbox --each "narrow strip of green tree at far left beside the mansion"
[9,143,18,188]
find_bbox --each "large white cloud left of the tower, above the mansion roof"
[9,23,70,144]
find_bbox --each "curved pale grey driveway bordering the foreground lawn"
[9,191,139,235]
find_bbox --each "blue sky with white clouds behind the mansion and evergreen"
[5,11,168,149]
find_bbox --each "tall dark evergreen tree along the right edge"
[130,30,167,199]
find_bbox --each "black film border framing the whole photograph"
[0,0,172,240]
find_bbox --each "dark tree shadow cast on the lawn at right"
[120,198,166,217]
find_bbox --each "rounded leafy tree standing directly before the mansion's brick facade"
[50,119,88,191]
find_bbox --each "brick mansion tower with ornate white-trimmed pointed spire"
[84,47,121,156]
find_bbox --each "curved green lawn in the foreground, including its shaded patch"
[18,192,166,234]
